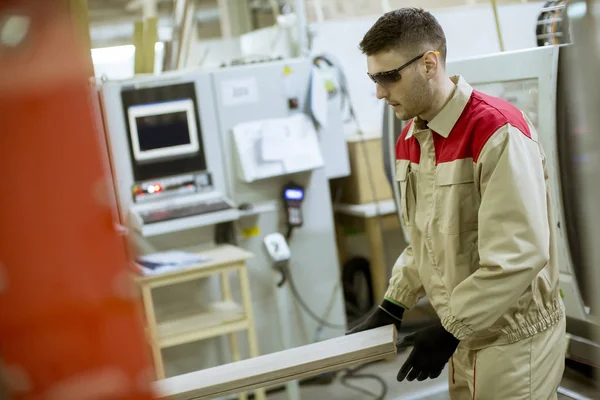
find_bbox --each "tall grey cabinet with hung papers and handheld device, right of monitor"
[212,59,350,360]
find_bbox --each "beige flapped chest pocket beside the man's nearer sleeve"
[434,158,480,234]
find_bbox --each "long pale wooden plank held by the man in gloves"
[155,325,397,400]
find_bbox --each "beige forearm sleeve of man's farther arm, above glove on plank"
[385,245,425,309]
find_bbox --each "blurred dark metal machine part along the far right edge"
[559,0,600,372]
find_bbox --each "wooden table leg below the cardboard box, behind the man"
[365,216,388,303]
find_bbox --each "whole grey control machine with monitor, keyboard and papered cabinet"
[101,59,350,375]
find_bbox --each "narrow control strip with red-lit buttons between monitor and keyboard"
[131,172,213,203]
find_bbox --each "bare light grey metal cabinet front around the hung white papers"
[213,60,345,353]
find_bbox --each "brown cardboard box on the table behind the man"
[341,137,394,204]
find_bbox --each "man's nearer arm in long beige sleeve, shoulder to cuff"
[442,125,550,340]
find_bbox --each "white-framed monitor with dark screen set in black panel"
[120,83,209,183]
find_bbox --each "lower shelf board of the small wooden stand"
[157,302,248,348]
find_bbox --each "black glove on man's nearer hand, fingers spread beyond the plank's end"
[397,324,459,382]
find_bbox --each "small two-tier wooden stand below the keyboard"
[136,245,266,400]
